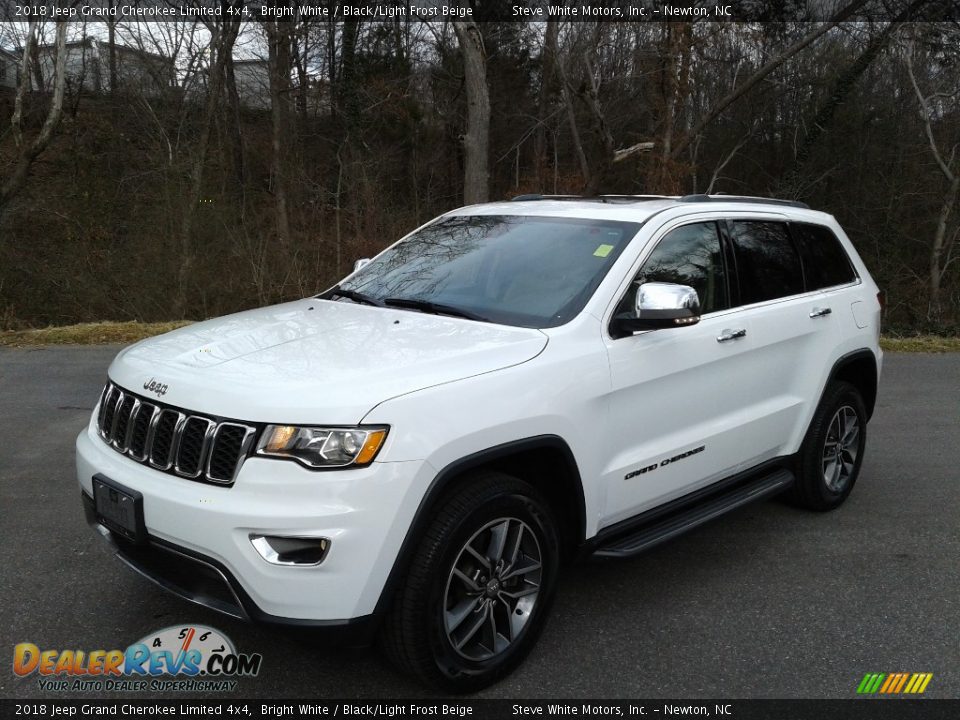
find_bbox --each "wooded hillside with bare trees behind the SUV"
[0,11,960,333]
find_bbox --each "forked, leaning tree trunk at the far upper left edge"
[0,21,67,219]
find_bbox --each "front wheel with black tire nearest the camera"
[381,471,560,693]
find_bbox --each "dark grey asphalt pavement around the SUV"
[0,347,960,698]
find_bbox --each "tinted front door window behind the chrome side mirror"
[618,223,730,314]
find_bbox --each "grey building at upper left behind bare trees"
[33,37,175,95]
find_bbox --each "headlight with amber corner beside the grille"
[257,425,387,468]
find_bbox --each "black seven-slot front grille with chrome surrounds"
[97,382,257,485]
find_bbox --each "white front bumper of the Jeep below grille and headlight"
[77,423,433,627]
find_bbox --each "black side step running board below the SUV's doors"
[593,469,794,557]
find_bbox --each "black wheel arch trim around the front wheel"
[374,435,586,622]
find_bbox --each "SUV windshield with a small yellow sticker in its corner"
[334,215,640,328]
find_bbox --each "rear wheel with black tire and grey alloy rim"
[790,382,867,512]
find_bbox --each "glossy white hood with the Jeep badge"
[110,299,547,424]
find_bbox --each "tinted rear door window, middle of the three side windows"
[730,220,803,305]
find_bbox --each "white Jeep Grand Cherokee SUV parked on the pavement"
[77,195,881,691]
